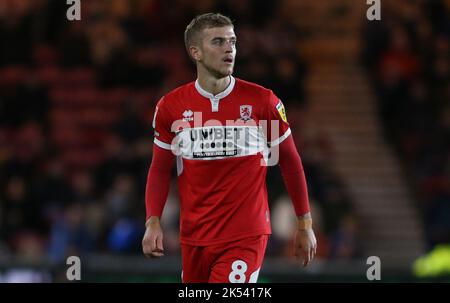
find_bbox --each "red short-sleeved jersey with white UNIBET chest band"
[153,76,290,246]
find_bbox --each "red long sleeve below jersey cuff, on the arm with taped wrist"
[279,136,310,216]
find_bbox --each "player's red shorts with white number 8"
[181,235,269,283]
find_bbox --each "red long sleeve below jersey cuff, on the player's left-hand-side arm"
[145,145,174,221]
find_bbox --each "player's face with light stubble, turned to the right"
[198,26,236,78]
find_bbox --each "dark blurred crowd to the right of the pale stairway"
[363,1,450,248]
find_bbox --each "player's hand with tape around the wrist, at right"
[294,217,317,267]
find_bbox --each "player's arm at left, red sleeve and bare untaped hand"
[142,144,175,257]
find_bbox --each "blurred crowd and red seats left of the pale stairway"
[0,0,356,260]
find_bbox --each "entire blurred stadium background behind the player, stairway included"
[0,0,450,282]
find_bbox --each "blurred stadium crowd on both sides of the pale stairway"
[0,0,450,268]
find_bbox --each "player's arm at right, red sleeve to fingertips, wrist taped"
[279,136,317,266]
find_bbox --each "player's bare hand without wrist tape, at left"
[142,217,164,258]
